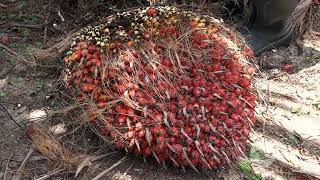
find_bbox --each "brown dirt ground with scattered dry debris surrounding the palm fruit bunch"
[0,0,320,180]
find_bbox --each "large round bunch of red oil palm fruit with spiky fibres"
[64,6,255,170]
